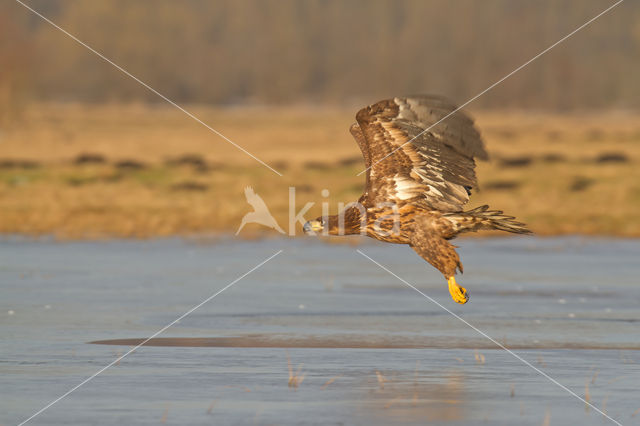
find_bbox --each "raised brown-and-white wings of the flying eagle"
[350,96,488,212]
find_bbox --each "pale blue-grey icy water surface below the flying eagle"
[0,237,640,426]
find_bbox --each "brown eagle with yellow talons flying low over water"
[304,96,531,304]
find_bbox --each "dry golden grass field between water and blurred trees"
[0,104,640,239]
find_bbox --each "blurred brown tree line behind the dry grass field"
[0,0,640,109]
